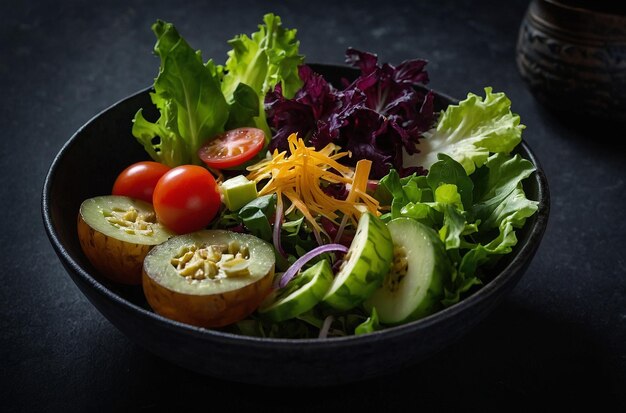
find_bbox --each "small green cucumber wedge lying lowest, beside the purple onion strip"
[258,260,333,322]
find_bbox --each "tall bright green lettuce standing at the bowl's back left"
[132,14,304,167]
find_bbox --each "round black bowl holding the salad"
[42,65,549,386]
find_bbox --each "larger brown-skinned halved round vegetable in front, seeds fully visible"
[143,230,275,328]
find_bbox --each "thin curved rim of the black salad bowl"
[41,64,550,348]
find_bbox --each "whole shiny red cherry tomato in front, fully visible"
[152,165,222,234]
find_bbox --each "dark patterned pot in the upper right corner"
[517,0,626,122]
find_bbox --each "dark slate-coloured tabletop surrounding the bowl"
[0,0,626,411]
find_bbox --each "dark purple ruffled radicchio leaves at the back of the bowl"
[266,49,435,179]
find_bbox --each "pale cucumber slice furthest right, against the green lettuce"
[364,218,452,324]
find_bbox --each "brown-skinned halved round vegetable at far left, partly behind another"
[77,195,174,285]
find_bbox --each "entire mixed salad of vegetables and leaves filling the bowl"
[78,14,537,338]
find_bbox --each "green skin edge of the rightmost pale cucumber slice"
[364,218,453,325]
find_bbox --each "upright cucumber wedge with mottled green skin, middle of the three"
[323,212,393,311]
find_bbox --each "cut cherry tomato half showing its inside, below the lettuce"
[198,128,265,169]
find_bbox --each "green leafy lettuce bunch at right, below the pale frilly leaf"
[380,153,537,306]
